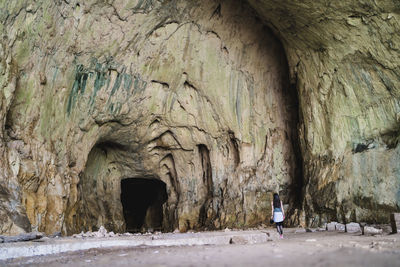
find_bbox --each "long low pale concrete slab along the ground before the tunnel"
[0,230,275,260]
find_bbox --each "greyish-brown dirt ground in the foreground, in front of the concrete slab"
[0,232,400,267]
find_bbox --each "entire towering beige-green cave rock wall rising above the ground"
[0,0,400,234]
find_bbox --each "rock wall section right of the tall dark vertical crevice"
[249,0,400,224]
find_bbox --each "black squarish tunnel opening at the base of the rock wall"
[121,178,168,232]
